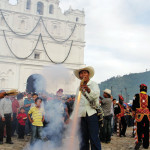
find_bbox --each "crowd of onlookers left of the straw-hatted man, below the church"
[0,89,75,144]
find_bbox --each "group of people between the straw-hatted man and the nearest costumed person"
[100,89,134,143]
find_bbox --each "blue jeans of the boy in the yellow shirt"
[30,125,43,145]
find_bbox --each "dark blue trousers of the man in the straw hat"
[80,114,101,150]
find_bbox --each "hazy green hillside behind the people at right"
[99,71,150,102]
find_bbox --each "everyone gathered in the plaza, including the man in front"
[0,67,150,150]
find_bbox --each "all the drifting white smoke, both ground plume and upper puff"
[24,65,79,150]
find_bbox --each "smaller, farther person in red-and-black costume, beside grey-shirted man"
[114,95,127,137]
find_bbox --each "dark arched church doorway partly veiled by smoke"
[26,74,46,93]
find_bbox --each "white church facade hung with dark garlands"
[0,0,85,94]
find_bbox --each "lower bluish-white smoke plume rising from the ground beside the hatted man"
[24,97,79,150]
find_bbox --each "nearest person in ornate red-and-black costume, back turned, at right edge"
[132,84,150,150]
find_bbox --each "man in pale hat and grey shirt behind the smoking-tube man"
[100,89,112,143]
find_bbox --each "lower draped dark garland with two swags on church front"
[3,30,73,64]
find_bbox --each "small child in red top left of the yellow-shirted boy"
[17,107,27,139]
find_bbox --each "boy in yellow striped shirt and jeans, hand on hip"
[28,97,44,145]
